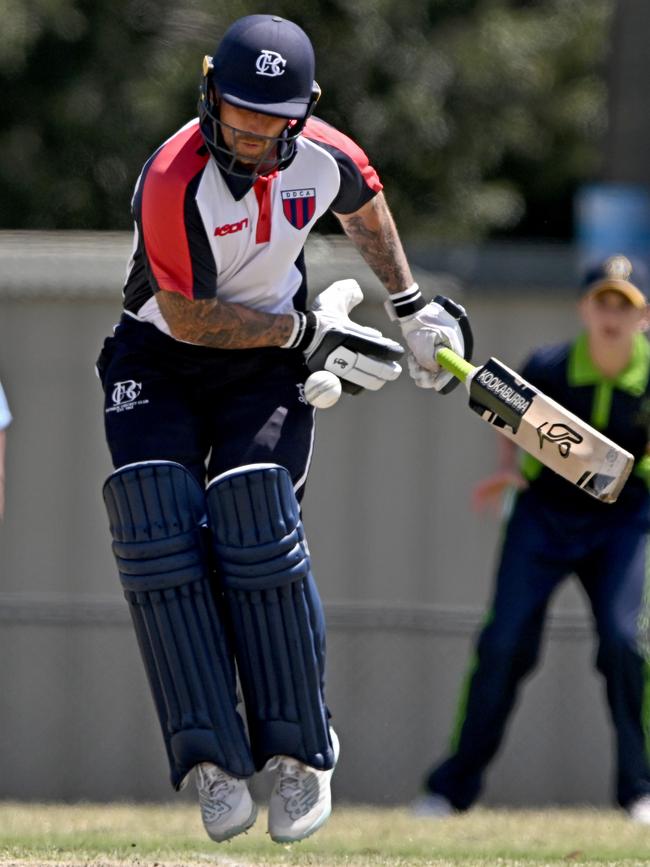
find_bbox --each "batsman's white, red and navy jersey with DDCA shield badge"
[124,112,382,333]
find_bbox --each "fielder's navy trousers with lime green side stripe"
[427,490,650,810]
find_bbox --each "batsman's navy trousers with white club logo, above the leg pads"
[97,315,314,500]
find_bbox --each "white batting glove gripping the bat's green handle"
[384,283,474,394]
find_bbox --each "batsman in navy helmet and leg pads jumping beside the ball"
[98,15,467,843]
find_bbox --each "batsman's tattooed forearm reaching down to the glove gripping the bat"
[336,193,413,295]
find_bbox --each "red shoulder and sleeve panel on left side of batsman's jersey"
[142,122,209,298]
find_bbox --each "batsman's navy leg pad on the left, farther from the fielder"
[104,461,254,788]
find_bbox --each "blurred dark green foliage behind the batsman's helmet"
[0,0,613,239]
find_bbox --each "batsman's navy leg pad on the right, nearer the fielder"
[207,464,334,769]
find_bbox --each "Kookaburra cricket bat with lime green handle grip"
[436,347,634,503]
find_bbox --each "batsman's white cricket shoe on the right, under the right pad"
[266,729,340,843]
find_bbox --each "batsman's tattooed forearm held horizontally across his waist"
[156,289,294,349]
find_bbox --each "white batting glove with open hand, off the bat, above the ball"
[284,279,404,394]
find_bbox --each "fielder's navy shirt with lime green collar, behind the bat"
[521,334,650,514]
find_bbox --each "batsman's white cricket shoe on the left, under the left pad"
[196,762,257,843]
